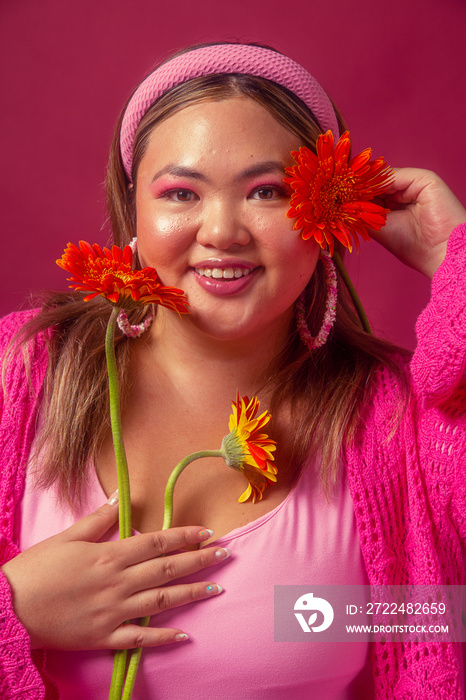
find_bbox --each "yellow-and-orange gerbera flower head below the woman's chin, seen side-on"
[222,392,277,503]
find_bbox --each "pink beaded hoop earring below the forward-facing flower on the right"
[296,250,338,351]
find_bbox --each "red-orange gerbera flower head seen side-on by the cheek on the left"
[57,241,189,313]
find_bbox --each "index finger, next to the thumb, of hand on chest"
[119,525,214,566]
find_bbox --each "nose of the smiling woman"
[196,197,251,250]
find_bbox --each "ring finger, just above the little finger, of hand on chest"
[122,581,223,620]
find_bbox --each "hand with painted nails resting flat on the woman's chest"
[2,504,228,650]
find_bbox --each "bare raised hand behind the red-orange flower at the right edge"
[370,168,466,278]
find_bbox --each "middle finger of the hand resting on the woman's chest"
[125,547,230,595]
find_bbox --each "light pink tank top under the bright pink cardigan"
[19,460,372,700]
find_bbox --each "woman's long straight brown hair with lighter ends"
[10,52,406,503]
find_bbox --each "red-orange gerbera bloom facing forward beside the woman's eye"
[284,131,393,255]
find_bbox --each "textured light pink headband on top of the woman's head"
[120,44,339,180]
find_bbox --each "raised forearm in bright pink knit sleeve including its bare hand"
[371,168,466,402]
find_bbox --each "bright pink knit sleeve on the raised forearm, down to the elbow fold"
[411,224,466,404]
